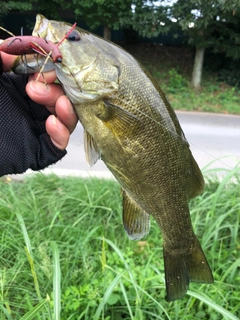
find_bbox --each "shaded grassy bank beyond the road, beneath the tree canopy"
[126,45,240,114]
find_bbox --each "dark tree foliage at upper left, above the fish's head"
[0,0,132,39]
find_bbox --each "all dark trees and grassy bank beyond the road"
[0,0,240,114]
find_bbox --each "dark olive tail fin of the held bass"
[163,238,213,301]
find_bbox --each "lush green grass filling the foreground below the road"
[0,169,240,320]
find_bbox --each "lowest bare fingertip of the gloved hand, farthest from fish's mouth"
[46,115,70,150]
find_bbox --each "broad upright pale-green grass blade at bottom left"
[51,241,61,320]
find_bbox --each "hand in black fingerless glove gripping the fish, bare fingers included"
[0,53,77,176]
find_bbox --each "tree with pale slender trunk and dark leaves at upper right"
[171,0,240,89]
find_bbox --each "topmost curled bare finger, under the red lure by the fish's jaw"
[26,80,64,112]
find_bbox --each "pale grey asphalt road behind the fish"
[36,112,240,176]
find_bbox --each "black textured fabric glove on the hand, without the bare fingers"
[0,73,66,176]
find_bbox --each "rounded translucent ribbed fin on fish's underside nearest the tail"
[123,190,150,240]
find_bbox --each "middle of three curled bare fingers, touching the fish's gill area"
[55,96,78,133]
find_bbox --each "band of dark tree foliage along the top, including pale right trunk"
[0,0,240,89]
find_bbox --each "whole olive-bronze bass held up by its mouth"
[12,15,213,301]
